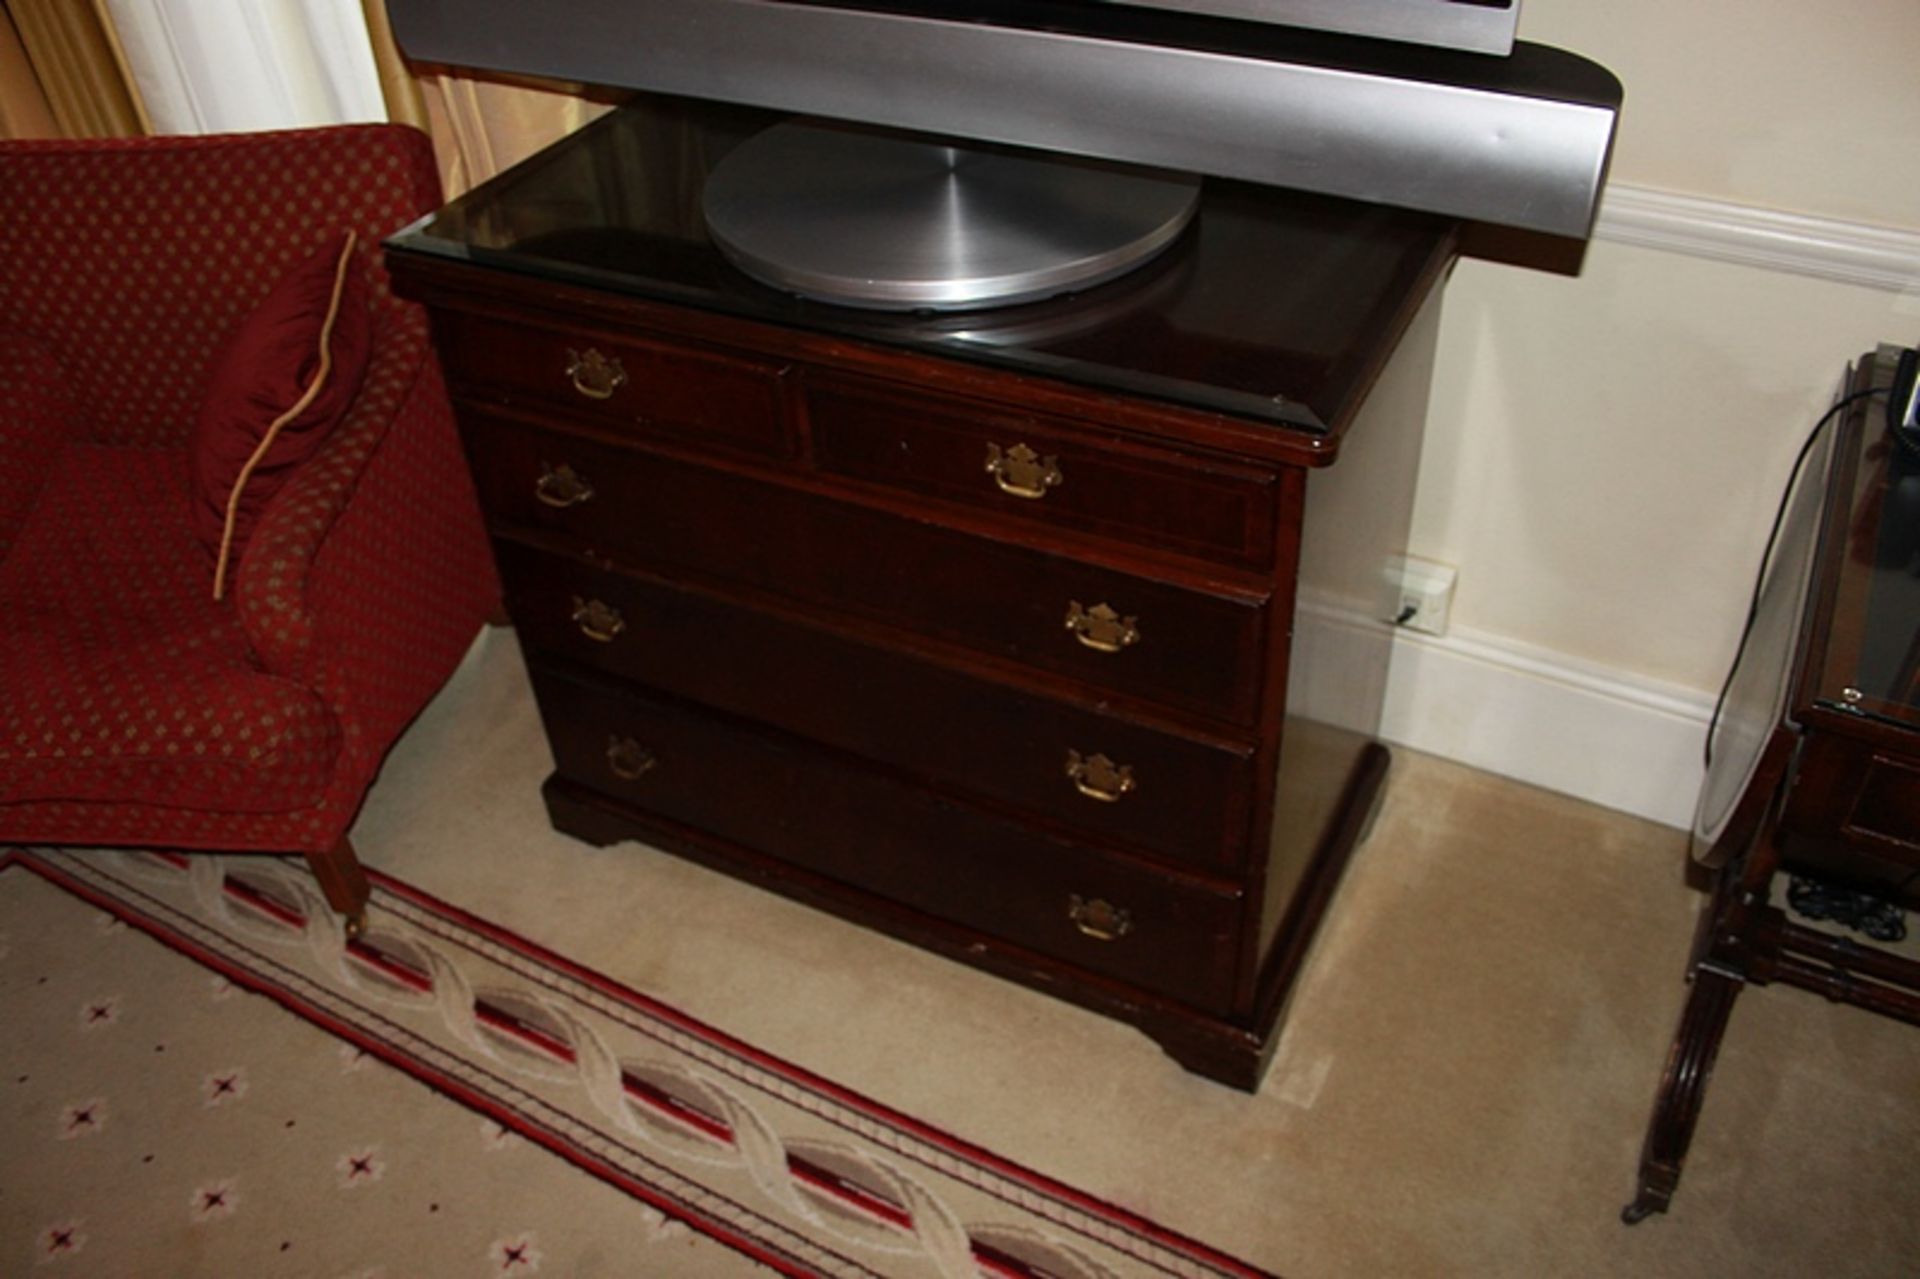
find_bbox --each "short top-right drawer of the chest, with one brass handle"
[806,376,1279,568]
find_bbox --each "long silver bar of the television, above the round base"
[388,0,1620,238]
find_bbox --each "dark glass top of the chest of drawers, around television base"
[388,96,1455,434]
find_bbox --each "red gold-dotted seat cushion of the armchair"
[0,444,342,806]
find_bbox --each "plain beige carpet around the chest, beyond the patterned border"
[22,630,1920,1279]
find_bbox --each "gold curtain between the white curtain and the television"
[361,0,607,200]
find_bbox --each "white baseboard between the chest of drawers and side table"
[1382,630,1713,828]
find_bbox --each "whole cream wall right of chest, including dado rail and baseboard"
[1390,0,1920,822]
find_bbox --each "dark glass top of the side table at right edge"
[1814,348,1920,730]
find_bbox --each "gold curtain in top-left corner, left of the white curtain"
[0,0,152,138]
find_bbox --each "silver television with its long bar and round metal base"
[388,0,1620,309]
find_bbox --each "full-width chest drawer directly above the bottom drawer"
[495,538,1252,872]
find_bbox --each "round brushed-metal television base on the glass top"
[705,121,1200,311]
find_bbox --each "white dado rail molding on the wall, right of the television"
[1594,182,1920,294]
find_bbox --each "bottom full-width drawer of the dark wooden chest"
[532,664,1240,1012]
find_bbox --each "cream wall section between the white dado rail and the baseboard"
[1413,242,1896,689]
